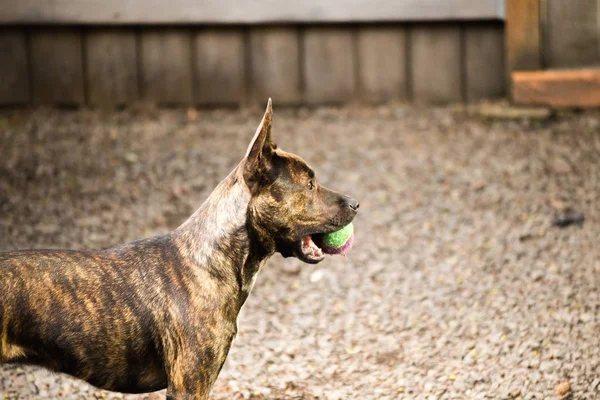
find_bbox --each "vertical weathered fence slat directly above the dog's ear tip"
[250,27,302,104]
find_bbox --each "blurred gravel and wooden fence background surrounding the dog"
[0,0,600,400]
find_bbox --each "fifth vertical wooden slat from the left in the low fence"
[193,28,245,105]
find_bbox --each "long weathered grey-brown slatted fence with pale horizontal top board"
[0,0,506,106]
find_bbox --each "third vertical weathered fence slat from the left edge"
[86,28,139,106]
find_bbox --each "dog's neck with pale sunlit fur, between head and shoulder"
[173,168,274,302]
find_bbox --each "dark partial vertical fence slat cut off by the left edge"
[0,28,29,105]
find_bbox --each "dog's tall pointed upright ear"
[244,99,275,189]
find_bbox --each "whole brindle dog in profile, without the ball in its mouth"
[0,99,358,399]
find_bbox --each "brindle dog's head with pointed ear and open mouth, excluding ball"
[241,99,358,264]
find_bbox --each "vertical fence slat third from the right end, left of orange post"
[358,27,407,103]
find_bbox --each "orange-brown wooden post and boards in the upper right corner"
[506,0,600,108]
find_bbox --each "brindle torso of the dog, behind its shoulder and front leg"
[0,236,179,392]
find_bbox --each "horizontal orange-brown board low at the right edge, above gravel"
[512,69,600,108]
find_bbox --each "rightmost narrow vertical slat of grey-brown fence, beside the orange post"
[465,24,506,101]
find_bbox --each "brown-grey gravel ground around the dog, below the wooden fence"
[0,103,600,399]
